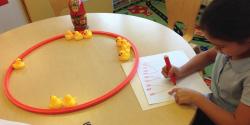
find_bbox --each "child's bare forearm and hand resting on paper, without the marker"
[169,88,250,125]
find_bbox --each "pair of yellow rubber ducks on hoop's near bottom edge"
[49,94,77,109]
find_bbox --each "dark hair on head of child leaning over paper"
[200,0,250,42]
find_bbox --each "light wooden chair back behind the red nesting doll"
[24,0,113,22]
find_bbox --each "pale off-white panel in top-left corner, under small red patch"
[0,0,28,33]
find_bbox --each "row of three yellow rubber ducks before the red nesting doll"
[64,30,93,41]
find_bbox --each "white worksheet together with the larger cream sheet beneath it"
[122,51,210,110]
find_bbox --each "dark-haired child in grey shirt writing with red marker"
[162,0,250,125]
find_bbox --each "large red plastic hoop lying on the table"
[3,31,139,115]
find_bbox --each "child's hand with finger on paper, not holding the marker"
[168,88,203,105]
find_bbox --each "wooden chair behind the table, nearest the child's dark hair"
[165,0,201,42]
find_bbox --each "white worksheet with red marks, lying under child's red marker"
[138,51,192,104]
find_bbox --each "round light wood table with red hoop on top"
[0,13,195,125]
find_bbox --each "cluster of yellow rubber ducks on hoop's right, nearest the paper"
[116,37,131,61]
